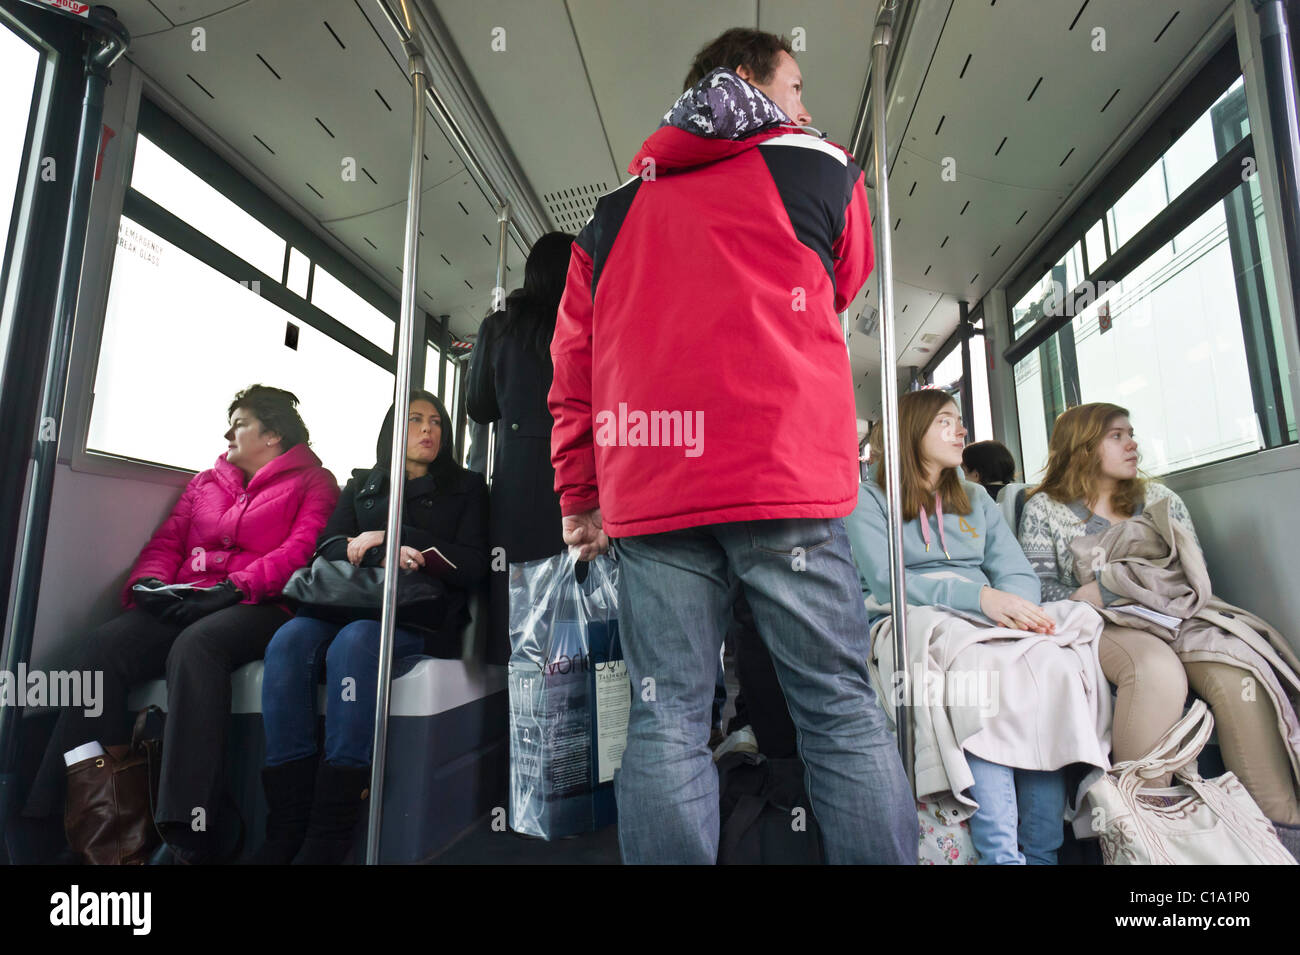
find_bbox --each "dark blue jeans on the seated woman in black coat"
[261,616,424,768]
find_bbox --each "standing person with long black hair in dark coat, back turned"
[465,233,573,664]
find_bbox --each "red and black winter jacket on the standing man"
[549,74,872,537]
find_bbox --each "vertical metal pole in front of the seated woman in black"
[365,45,426,865]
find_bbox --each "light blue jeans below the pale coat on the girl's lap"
[966,752,1065,865]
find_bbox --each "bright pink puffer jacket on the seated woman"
[122,444,338,607]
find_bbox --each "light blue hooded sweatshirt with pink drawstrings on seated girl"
[845,466,1041,625]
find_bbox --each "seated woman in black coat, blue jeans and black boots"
[256,391,488,864]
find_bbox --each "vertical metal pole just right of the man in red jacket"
[871,0,915,785]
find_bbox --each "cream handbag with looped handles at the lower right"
[1087,700,1296,865]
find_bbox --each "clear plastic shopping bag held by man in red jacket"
[507,552,632,839]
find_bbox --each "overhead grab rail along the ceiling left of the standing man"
[374,0,550,254]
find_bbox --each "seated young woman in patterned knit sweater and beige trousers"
[1019,403,1300,826]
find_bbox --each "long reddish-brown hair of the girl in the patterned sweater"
[1024,401,1147,517]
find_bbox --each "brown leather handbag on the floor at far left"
[64,707,161,865]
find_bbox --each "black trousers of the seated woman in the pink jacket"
[23,604,291,830]
